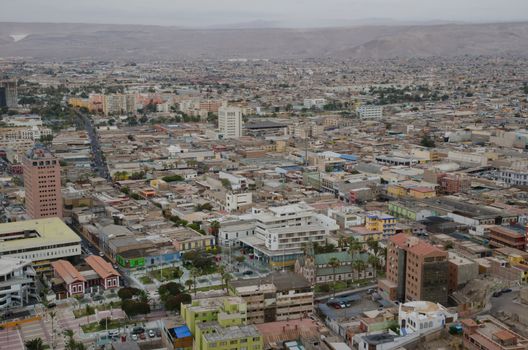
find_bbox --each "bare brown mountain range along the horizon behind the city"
[0,22,528,61]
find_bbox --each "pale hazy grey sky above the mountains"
[0,0,528,27]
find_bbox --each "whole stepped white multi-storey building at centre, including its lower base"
[240,203,339,268]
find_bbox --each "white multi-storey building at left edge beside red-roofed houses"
[0,256,38,311]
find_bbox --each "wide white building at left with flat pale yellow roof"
[0,218,81,272]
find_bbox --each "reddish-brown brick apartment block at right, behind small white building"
[378,233,449,305]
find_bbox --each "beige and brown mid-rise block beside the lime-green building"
[229,271,313,324]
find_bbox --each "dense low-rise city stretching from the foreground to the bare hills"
[0,7,528,350]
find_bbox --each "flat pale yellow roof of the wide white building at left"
[0,218,81,252]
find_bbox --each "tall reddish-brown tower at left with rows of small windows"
[22,147,62,219]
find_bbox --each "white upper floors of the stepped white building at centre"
[255,203,338,251]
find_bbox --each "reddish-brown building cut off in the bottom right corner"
[462,316,528,350]
